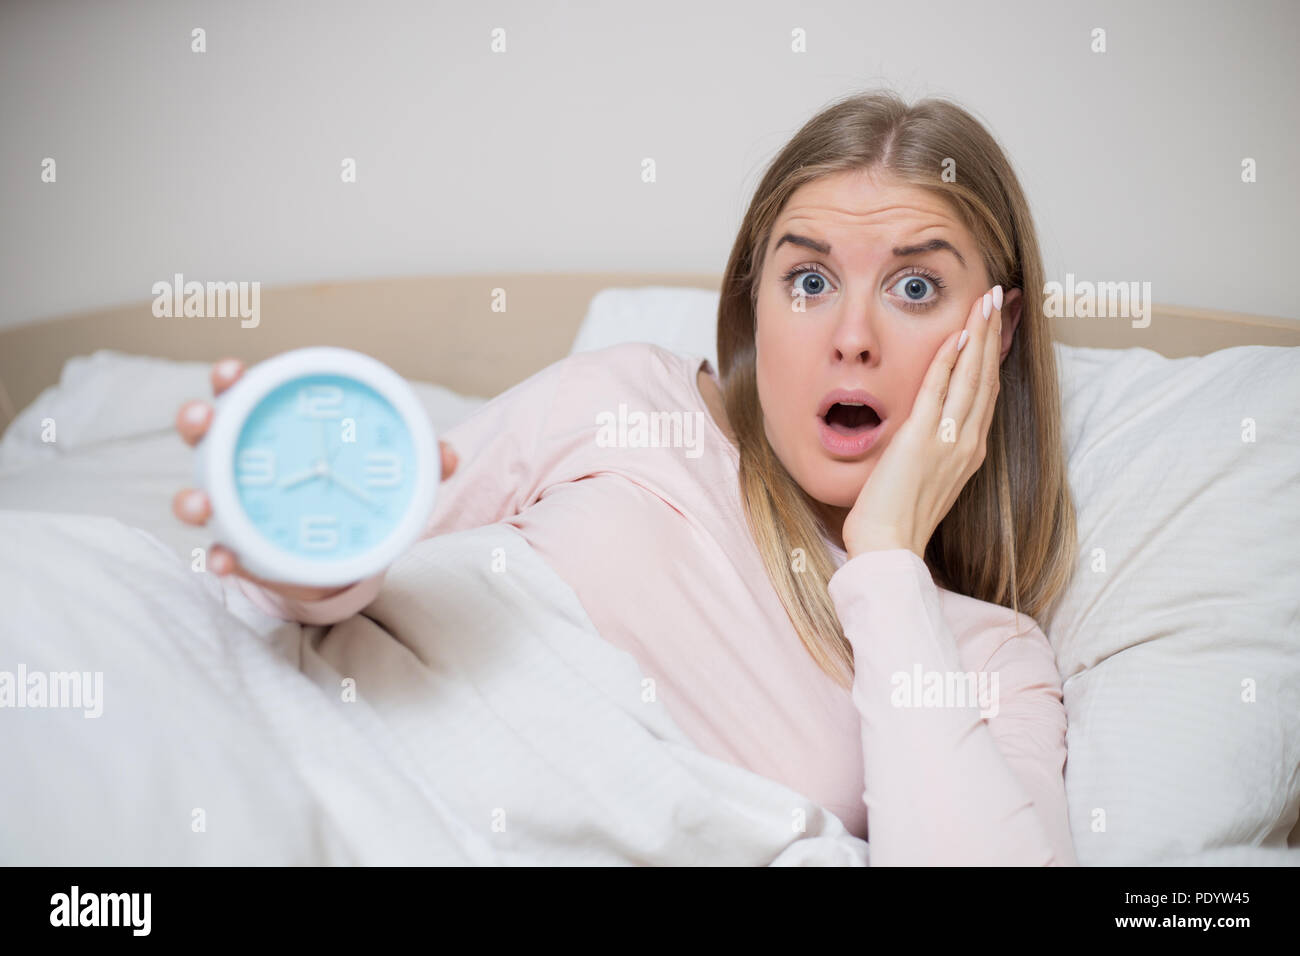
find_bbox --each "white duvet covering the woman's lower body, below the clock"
[0,511,868,865]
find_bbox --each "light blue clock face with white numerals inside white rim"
[233,375,419,561]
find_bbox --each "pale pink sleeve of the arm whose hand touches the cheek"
[829,549,1076,866]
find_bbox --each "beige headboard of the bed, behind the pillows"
[0,272,1300,428]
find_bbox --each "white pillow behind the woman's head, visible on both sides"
[573,287,1300,865]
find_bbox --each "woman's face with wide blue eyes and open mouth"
[755,172,1018,535]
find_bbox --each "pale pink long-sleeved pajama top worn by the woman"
[237,343,1076,866]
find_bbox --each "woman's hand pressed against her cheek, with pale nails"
[844,286,1002,559]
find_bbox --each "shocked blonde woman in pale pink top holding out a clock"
[173,94,1076,865]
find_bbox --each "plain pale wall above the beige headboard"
[0,0,1300,325]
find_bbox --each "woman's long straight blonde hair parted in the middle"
[718,91,1078,687]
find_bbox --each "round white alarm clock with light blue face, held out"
[194,346,442,587]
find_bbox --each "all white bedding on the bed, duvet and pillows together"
[0,278,1300,865]
